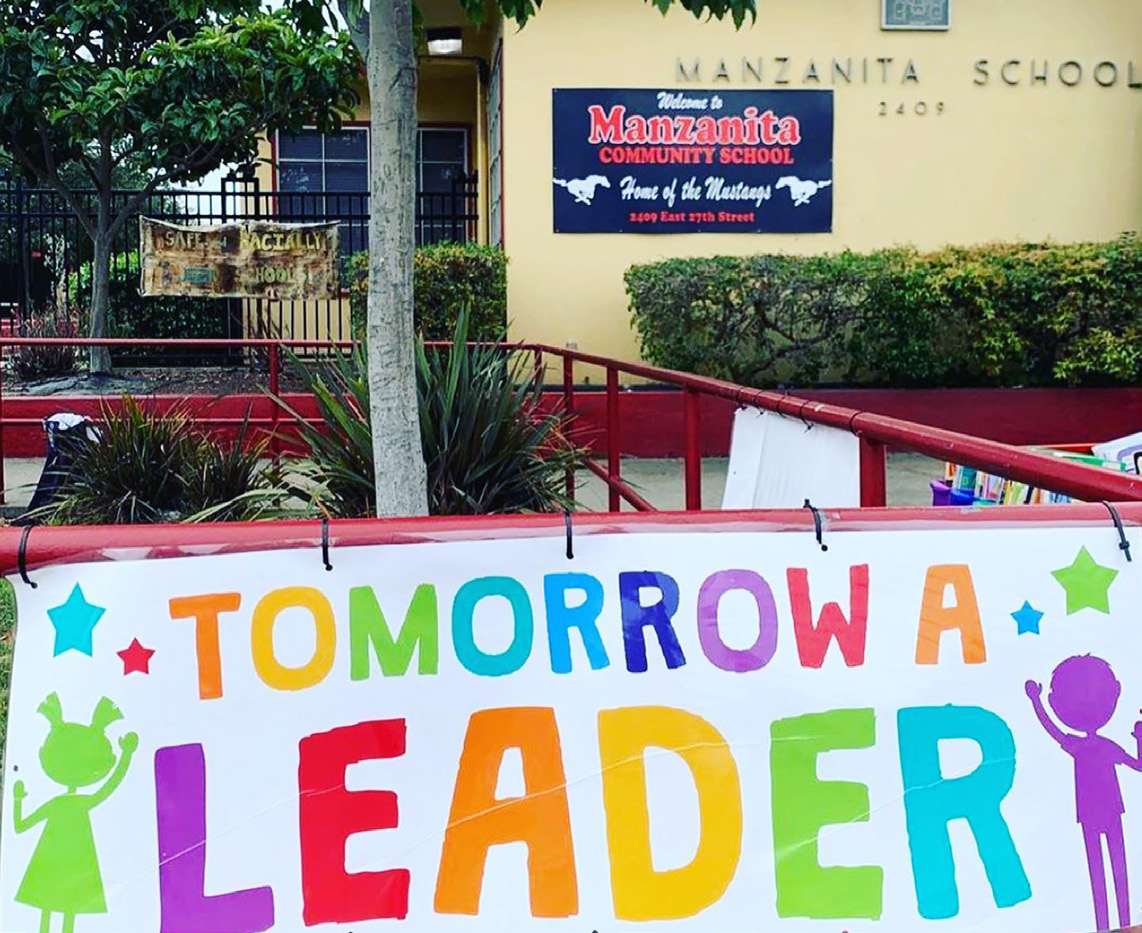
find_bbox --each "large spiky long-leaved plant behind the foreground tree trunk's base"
[279,314,586,517]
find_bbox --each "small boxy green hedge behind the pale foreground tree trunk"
[346,243,507,340]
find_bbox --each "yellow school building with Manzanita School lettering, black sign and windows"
[256,0,1142,359]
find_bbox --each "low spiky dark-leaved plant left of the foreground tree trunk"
[25,395,284,525]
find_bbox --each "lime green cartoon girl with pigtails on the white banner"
[13,693,139,933]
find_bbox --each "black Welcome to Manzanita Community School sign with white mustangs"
[553,88,834,233]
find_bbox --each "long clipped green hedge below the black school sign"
[626,235,1142,386]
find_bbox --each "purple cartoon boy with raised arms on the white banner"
[1027,654,1142,931]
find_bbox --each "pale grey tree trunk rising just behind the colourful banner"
[365,0,428,517]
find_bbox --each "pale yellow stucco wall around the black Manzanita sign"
[504,0,1142,359]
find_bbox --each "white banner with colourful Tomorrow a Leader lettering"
[0,521,1142,933]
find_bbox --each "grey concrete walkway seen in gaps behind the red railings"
[3,453,943,512]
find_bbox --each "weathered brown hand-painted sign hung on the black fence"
[140,217,338,299]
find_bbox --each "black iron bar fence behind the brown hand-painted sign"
[0,176,478,364]
